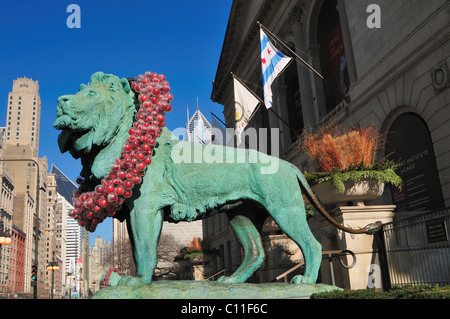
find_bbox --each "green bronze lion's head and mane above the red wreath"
[53,72,136,178]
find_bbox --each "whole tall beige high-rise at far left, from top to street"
[1,77,48,295]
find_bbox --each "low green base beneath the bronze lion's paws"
[93,280,342,299]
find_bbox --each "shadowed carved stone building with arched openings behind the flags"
[209,0,450,286]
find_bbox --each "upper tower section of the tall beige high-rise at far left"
[5,77,41,157]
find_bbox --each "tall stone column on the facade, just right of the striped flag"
[289,9,318,129]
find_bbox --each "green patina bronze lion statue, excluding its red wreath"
[54,72,378,298]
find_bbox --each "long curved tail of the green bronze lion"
[297,170,381,234]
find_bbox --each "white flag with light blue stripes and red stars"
[261,28,291,109]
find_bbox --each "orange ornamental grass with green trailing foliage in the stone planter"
[300,126,402,194]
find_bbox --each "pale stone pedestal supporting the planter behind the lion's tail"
[310,205,395,289]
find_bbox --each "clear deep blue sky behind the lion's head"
[0,0,232,242]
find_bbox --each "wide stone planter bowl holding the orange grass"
[312,178,384,207]
